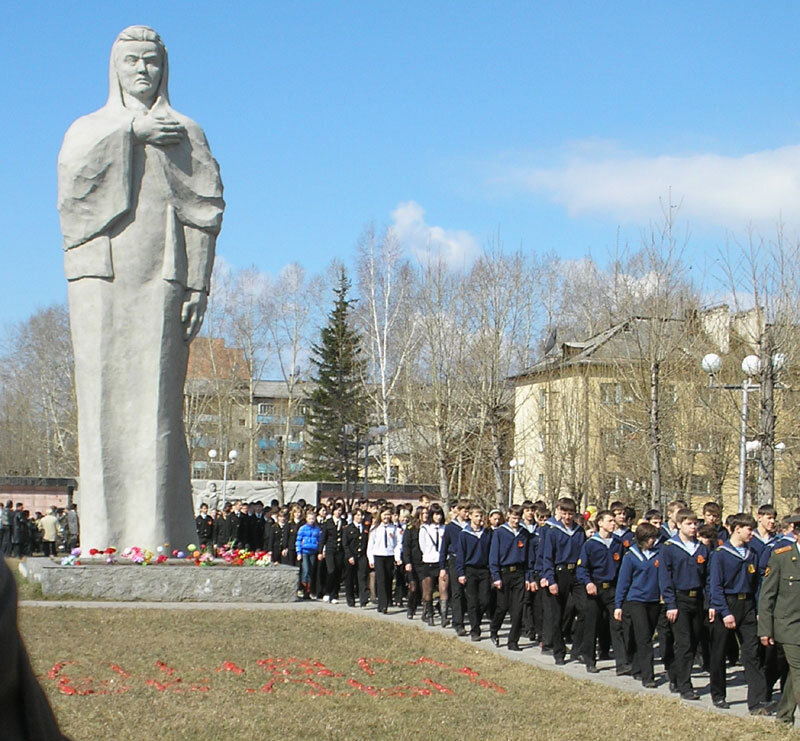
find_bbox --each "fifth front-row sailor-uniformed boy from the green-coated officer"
[540,497,586,665]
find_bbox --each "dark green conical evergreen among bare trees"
[307,268,367,481]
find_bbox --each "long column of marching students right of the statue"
[196,496,800,723]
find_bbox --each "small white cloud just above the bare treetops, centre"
[391,201,480,268]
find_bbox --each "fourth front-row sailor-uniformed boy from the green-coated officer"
[573,509,631,675]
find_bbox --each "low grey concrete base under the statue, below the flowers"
[20,558,297,602]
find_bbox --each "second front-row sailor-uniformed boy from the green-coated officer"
[656,509,708,700]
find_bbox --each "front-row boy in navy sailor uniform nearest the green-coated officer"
[708,512,769,715]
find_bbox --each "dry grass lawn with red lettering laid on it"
[19,607,798,741]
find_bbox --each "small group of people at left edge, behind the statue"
[0,499,80,558]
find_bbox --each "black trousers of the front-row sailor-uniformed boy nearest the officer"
[709,594,767,710]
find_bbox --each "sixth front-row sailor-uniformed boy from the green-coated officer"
[489,504,533,651]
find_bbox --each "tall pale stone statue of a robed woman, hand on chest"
[58,26,225,548]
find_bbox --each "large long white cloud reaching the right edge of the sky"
[511,143,800,230]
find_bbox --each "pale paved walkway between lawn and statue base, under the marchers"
[20,600,792,722]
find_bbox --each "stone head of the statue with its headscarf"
[111,26,168,107]
